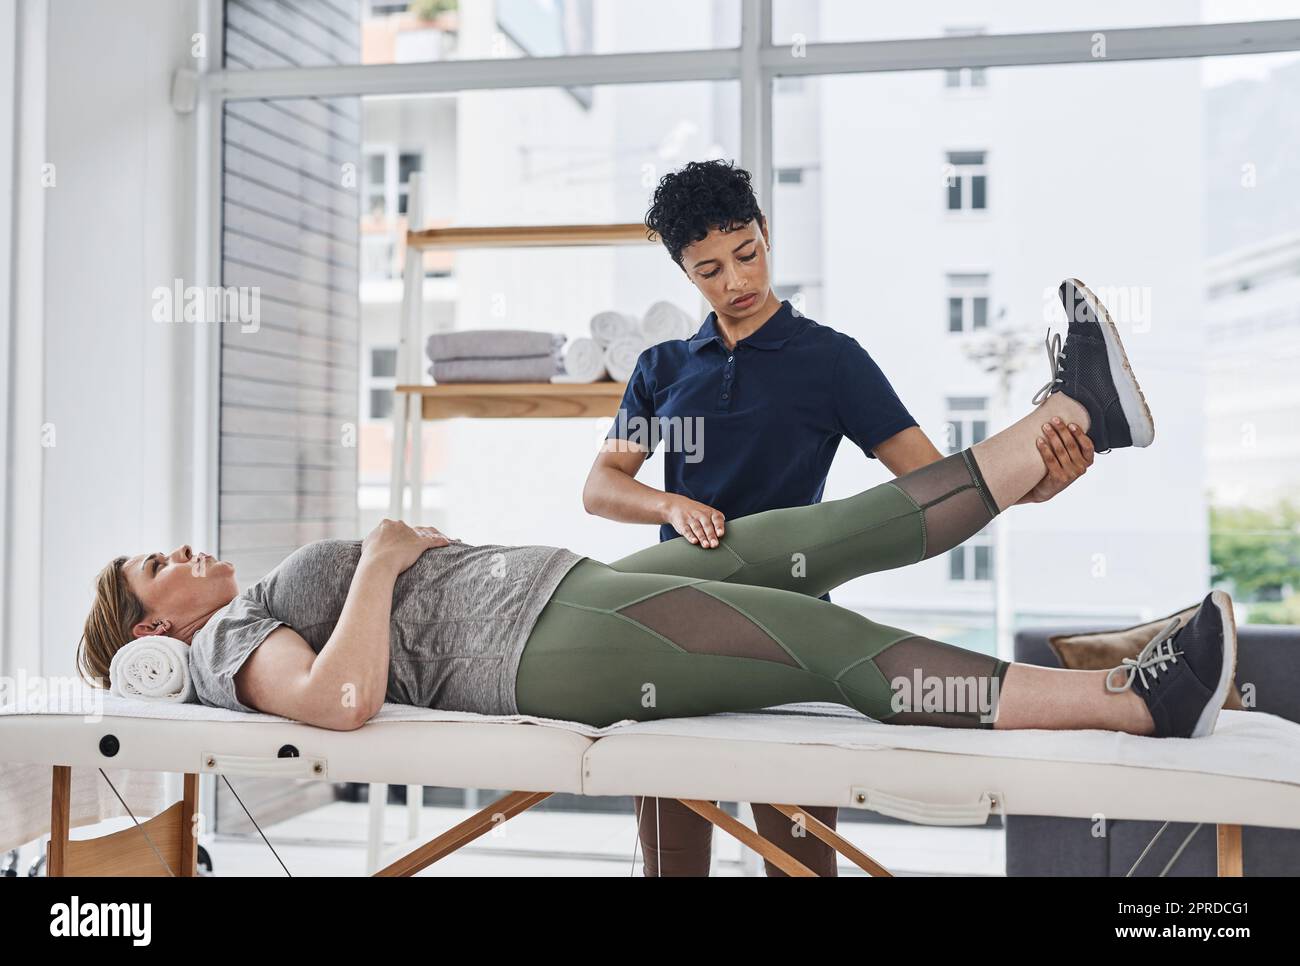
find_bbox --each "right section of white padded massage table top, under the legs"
[582,705,1300,828]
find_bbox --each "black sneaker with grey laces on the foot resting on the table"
[1106,590,1236,738]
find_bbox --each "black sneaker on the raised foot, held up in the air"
[1034,278,1156,452]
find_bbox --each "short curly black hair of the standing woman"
[646,160,766,272]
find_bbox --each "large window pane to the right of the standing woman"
[772,45,1300,646]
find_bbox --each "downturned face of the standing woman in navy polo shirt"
[681,218,771,321]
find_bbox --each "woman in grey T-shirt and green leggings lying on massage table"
[78,475,1235,737]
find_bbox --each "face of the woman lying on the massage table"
[122,543,239,640]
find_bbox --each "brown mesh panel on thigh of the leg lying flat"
[619,586,798,667]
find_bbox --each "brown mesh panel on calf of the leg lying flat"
[872,636,1010,728]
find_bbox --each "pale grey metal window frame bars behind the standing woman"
[188,0,1300,837]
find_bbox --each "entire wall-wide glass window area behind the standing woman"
[209,0,1300,878]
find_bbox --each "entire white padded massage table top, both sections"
[0,693,1300,842]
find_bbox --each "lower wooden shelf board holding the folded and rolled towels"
[394,381,628,419]
